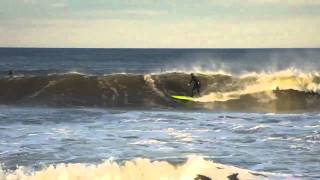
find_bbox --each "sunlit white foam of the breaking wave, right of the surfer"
[196,68,320,102]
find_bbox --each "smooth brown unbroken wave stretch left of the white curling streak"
[0,74,169,107]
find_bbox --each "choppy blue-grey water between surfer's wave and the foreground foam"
[0,107,320,179]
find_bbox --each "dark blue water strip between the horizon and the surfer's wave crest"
[0,48,320,75]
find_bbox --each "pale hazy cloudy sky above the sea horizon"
[0,0,320,48]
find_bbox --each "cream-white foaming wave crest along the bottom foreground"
[0,156,284,180]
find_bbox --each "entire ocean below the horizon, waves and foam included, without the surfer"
[0,48,320,180]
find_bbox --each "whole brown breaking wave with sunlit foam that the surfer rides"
[0,69,320,111]
